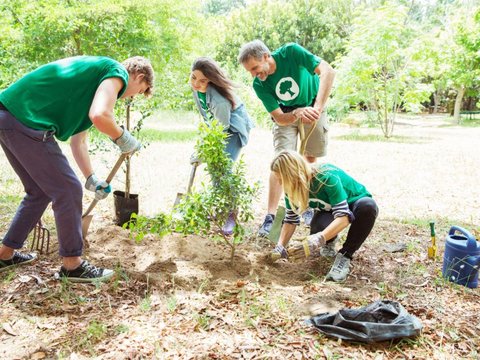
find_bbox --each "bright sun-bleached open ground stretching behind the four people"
[86,117,480,224]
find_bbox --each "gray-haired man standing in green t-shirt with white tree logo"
[238,40,335,236]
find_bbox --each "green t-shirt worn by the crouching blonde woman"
[285,164,372,211]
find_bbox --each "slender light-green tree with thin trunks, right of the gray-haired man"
[335,3,432,137]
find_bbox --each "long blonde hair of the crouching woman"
[270,150,317,214]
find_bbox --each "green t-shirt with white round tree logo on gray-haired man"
[253,43,322,113]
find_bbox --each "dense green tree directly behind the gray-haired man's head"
[217,0,353,68]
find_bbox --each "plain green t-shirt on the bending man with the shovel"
[0,56,128,141]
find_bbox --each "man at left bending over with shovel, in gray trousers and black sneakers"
[0,56,154,282]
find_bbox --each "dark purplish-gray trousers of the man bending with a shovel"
[0,104,83,257]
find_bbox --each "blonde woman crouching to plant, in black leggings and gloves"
[271,150,378,282]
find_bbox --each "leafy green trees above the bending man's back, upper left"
[0,0,203,108]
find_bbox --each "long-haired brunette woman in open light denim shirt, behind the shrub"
[190,57,254,235]
